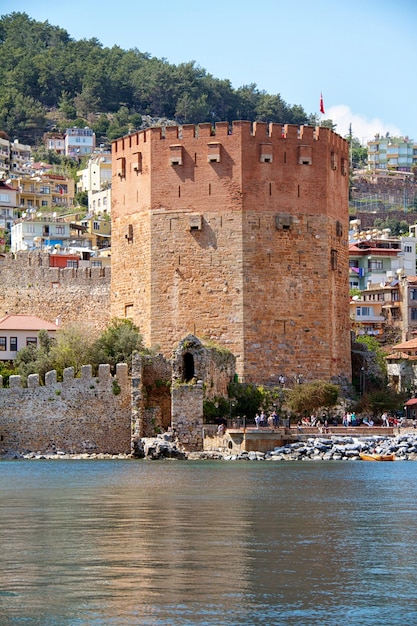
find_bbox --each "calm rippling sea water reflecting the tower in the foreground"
[0,460,417,626]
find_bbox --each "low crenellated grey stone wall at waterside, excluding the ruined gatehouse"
[0,364,131,455]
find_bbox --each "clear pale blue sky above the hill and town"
[0,0,417,142]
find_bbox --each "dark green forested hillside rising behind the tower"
[0,13,315,145]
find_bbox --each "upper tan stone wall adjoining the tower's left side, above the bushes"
[0,252,111,333]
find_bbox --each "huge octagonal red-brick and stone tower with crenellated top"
[111,122,351,383]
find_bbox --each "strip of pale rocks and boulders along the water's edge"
[2,431,417,461]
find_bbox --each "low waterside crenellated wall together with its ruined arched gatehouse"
[0,335,235,457]
